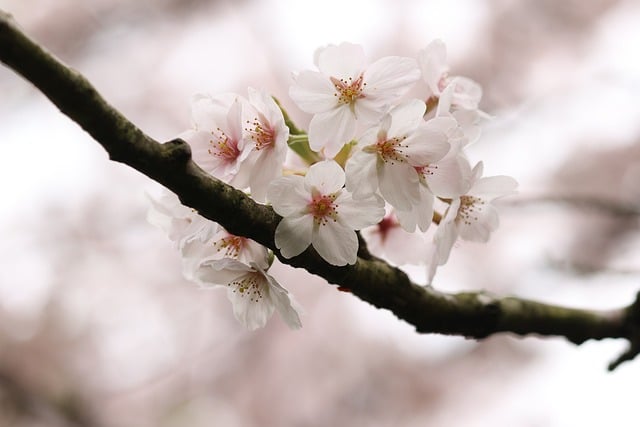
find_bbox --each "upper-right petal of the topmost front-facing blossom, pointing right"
[363,56,420,102]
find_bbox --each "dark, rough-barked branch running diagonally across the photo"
[0,11,640,372]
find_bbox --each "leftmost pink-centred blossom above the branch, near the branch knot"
[180,94,252,189]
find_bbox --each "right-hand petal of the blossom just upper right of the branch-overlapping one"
[402,126,451,166]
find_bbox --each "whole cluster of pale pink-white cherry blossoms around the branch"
[149,40,516,329]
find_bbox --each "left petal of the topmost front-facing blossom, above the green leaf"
[289,71,338,114]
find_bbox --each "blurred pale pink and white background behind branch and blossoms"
[0,0,640,427]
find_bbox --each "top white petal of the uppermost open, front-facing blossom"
[316,43,365,80]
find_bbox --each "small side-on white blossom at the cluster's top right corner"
[418,39,482,110]
